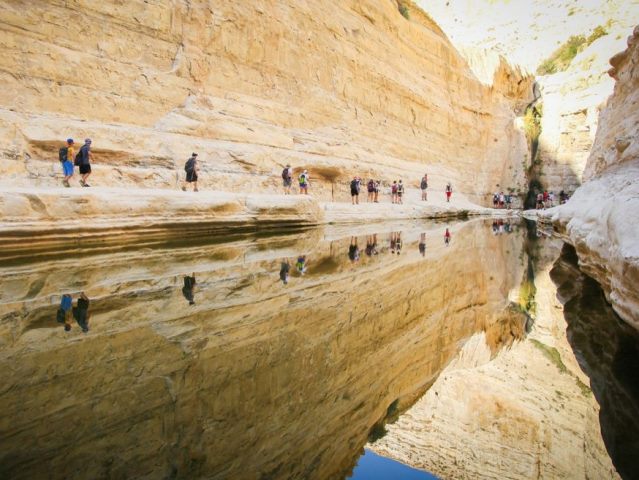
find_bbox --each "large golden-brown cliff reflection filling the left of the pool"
[0,222,525,479]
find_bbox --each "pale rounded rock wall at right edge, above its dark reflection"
[545,28,639,328]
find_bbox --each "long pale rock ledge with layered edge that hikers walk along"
[0,188,510,261]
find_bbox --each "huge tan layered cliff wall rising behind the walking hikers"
[0,0,531,199]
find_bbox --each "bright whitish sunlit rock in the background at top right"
[418,0,639,194]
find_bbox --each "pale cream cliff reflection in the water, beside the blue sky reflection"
[370,239,620,479]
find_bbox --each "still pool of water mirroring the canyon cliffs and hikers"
[0,219,639,479]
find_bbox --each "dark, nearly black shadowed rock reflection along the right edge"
[551,245,639,479]
